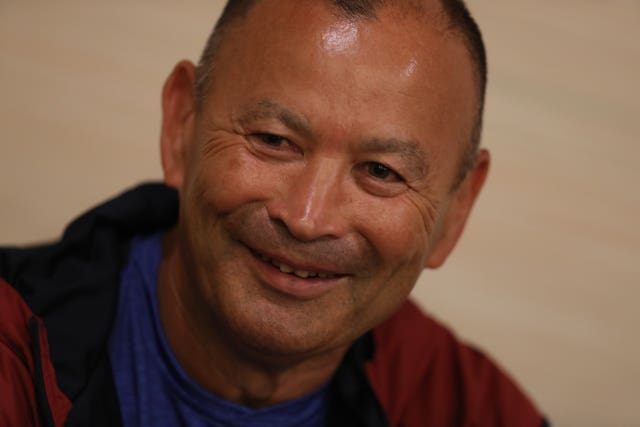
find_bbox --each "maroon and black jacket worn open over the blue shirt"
[0,184,546,427]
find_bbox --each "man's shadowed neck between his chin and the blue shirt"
[158,232,346,407]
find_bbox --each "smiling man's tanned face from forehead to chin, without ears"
[168,0,476,362]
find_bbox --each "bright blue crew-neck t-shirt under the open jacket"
[109,234,326,427]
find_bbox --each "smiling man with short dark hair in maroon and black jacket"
[0,0,544,426]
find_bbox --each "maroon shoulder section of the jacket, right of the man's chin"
[367,301,543,427]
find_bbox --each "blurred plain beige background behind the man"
[0,0,640,426]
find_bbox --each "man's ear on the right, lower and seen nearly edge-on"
[425,149,490,268]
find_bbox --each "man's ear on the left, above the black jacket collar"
[160,61,195,189]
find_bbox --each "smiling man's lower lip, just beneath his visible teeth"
[249,250,345,299]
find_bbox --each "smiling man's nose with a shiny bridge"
[267,159,347,241]
